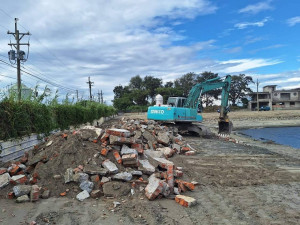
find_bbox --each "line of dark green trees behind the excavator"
[113,71,254,111]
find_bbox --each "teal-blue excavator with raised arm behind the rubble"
[147,75,232,136]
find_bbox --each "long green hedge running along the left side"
[0,100,116,140]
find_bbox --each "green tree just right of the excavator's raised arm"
[229,74,254,106]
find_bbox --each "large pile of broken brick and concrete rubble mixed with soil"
[0,118,197,207]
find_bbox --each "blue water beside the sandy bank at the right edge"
[240,127,300,149]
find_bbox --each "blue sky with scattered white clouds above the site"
[0,0,300,103]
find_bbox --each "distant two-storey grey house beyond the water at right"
[248,85,300,110]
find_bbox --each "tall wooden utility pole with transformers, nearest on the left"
[7,18,30,101]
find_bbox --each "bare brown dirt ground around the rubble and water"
[0,110,300,225]
